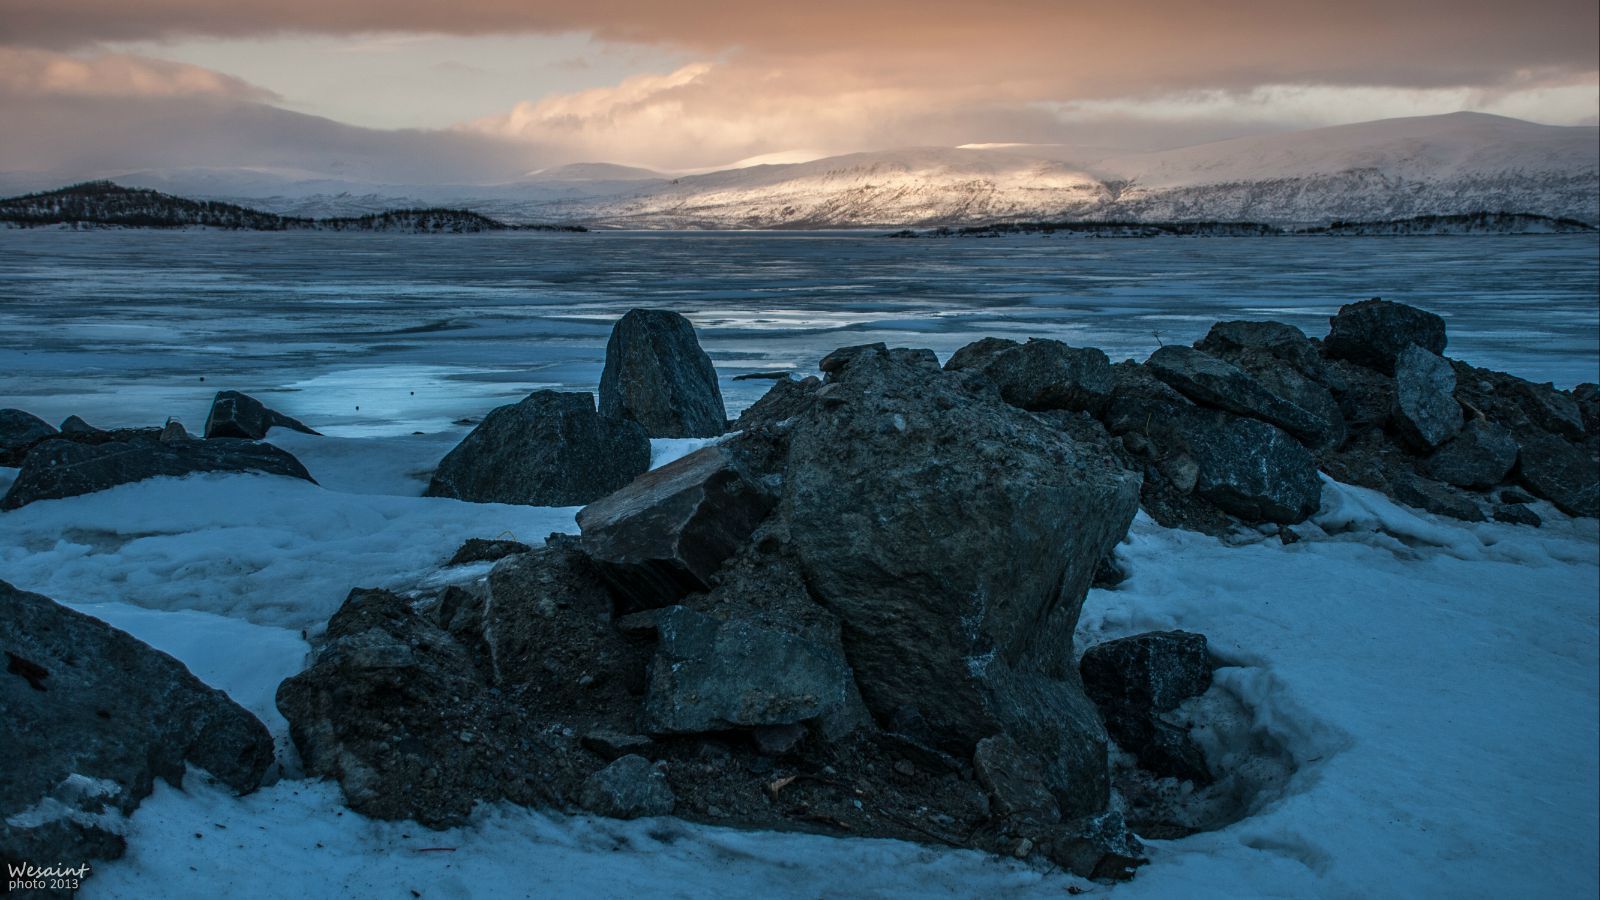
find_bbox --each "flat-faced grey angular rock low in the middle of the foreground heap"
[645,607,851,733]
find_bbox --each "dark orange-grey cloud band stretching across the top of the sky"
[0,0,1600,99]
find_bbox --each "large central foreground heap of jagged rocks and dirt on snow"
[278,339,1139,876]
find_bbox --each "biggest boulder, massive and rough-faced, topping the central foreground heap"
[779,341,1139,814]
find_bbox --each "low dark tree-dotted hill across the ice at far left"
[0,181,584,234]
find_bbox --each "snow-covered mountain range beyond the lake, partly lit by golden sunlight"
[34,112,1600,229]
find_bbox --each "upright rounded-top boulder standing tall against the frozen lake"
[600,309,728,437]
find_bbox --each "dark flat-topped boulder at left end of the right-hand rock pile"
[944,338,1112,413]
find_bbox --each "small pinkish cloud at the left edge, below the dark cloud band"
[0,46,278,101]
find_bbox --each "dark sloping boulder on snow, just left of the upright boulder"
[427,391,650,506]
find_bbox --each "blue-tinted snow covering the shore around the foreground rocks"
[0,425,1600,897]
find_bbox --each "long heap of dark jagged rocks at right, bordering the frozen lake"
[934,299,1600,533]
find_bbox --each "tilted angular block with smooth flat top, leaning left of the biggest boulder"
[578,447,774,609]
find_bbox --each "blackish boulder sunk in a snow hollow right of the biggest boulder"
[1078,631,1213,783]
